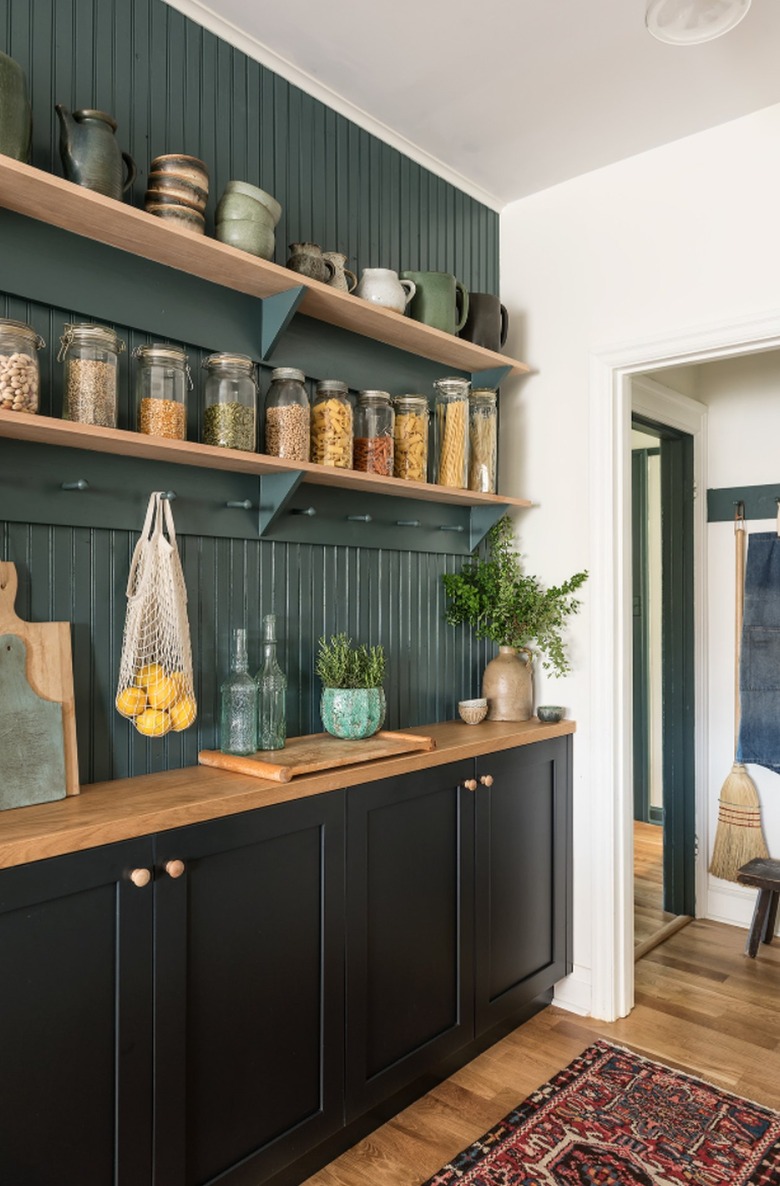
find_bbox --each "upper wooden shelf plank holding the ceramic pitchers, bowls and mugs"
[0,154,529,375]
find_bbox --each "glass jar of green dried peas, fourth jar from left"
[203,355,257,453]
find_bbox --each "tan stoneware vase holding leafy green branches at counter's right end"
[442,515,588,721]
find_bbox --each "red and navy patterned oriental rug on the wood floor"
[424,1041,780,1186]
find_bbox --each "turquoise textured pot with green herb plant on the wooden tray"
[315,633,385,741]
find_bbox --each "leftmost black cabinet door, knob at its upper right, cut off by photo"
[0,839,154,1186]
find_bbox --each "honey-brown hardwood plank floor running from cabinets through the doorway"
[301,920,780,1186]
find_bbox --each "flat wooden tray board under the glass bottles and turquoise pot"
[198,729,436,783]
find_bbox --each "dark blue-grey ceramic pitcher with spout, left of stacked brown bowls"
[55,103,136,199]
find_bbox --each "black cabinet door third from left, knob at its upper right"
[346,761,473,1120]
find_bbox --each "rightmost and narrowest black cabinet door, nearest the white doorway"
[474,737,571,1034]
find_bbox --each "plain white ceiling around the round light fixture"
[168,0,780,209]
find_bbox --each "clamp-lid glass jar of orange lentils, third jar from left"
[133,342,192,441]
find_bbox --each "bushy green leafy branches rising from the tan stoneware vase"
[442,515,588,675]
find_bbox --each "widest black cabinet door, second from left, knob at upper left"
[154,791,344,1186]
